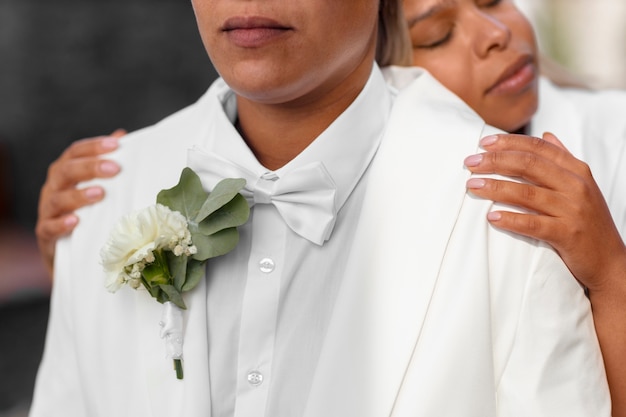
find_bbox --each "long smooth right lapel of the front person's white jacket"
[300,73,494,417]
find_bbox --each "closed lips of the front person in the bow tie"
[222,16,293,48]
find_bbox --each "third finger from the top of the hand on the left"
[39,186,104,221]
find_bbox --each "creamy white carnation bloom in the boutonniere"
[100,204,196,292]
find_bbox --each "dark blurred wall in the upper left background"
[0,0,216,227]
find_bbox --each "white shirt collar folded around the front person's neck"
[193,65,393,231]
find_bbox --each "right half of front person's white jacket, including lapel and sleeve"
[338,66,610,417]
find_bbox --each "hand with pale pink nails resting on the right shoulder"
[465,133,626,293]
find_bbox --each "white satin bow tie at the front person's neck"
[188,148,337,246]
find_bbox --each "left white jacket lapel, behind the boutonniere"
[135,87,221,417]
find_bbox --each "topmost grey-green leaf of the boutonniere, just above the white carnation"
[157,168,208,220]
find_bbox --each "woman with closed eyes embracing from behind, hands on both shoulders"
[37,0,626,415]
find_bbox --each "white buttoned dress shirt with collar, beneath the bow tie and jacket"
[190,70,391,417]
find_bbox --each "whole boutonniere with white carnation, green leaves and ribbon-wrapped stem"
[101,168,250,379]
